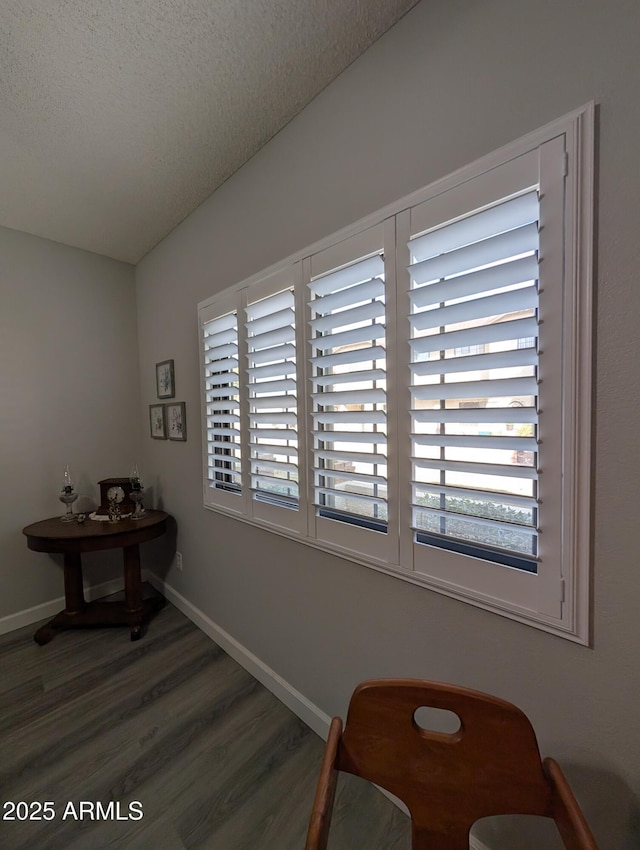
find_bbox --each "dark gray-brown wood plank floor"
[0,605,410,850]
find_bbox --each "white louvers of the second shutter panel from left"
[246,289,299,510]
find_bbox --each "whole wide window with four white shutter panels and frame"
[200,107,593,642]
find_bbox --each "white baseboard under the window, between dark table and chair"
[145,572,331,740]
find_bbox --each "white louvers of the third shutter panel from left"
[309,255,388,530]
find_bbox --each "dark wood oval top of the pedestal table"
[22,509,169,552]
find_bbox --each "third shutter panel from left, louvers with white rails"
[303,222,398,564]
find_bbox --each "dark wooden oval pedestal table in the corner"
[22,510,169,646]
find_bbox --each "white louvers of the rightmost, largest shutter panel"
[409,188,539,572]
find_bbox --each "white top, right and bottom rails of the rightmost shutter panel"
[398,134,574,629]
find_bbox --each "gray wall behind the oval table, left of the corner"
[0,228,141,619]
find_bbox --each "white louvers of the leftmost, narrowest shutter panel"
[203,311,242,493]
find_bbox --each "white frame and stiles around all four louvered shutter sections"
[198,103,595,645]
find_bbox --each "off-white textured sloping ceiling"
[0,0,417,262]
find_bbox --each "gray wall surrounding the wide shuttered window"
[137,0,640,850]
